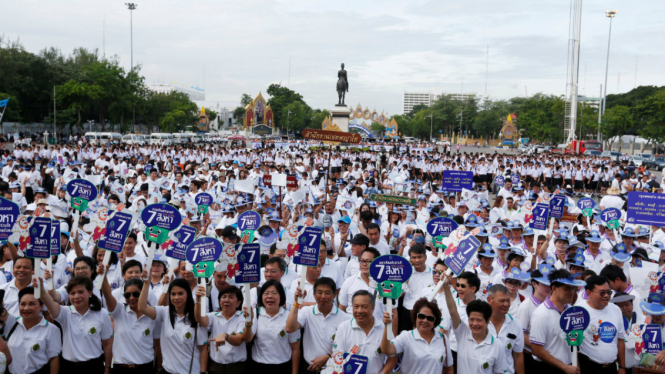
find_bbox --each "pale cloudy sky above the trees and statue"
[5,0,665,115]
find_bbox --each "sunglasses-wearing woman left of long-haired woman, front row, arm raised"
[97,268,160,374]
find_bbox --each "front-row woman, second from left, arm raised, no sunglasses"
[35,276,113,374]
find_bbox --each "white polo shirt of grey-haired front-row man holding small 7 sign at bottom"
[333,317,387,373]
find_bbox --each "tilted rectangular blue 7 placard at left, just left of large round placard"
[95,210,136,290]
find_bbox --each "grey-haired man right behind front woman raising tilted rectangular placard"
[487,284,524,374]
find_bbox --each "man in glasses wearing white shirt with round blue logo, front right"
[579,275,626,374]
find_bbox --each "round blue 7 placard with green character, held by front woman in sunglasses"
[369,255,413,339]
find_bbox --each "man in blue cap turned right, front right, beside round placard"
[529,269,586,374]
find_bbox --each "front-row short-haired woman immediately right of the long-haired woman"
[194,286,252,374]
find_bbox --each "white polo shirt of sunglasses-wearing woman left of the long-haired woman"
[111,303,161,365]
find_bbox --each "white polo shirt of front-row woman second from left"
[54,306,113,362]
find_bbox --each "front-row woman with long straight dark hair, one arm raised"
[138,271,208,374]
